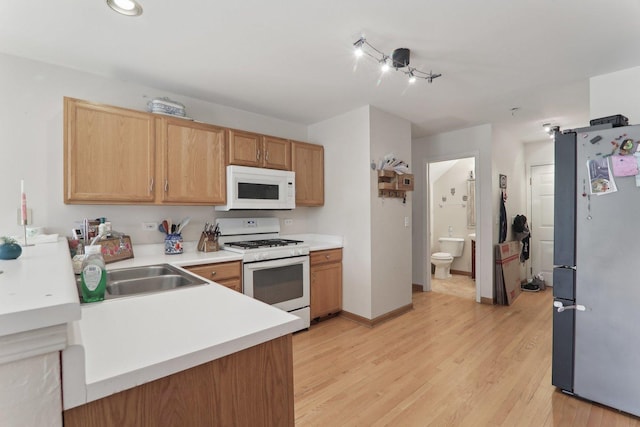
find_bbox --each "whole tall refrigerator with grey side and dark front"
[552,125,640,416]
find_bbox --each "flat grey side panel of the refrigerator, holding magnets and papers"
[573,126,640,416]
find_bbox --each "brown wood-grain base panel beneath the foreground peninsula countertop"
[63,334,295,427]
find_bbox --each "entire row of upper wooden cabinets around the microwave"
[64,98,324,206]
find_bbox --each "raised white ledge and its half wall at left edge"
[0,239,80,426]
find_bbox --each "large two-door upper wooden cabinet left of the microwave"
[64,98,226,205]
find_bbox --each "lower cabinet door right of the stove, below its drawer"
[311,262,342,319]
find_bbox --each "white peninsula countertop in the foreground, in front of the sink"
[62,284,302,409]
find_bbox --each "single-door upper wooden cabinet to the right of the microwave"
[291,141,324,206]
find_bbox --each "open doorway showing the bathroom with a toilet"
[424,156,480,301]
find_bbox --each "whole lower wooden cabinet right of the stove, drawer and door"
[310,249,342,319]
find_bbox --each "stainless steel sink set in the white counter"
[76,264,207,300]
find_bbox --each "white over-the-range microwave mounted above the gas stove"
[215,165,296,211]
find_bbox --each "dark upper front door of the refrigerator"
[553,133,580,270]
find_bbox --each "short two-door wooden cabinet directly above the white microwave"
[229,129,291,170]
